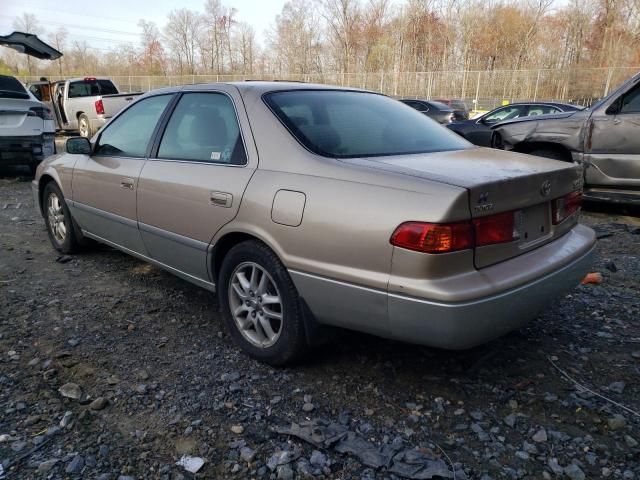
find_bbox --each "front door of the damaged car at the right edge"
[585,81,640,190]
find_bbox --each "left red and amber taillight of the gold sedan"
[390,212,520,253]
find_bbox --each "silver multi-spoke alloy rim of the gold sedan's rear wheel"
[229,262,283,348]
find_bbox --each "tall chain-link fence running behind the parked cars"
[23,67,639,110]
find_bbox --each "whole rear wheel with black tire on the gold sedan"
[218,240,308,366]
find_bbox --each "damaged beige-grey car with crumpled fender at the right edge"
[491,74,640,205]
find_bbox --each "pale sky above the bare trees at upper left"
[0,0,286,50]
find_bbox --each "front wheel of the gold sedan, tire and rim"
[42,182,82,254]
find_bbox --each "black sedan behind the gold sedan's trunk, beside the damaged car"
[447,102,582,147]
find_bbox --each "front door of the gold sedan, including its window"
[72,95,173,255]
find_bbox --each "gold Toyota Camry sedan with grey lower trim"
[33,82,595,365]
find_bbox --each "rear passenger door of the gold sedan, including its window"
[138,86,257,283]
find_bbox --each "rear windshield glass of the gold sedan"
[264,90,469,158]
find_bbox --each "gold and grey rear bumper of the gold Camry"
[289,225,595,350]
